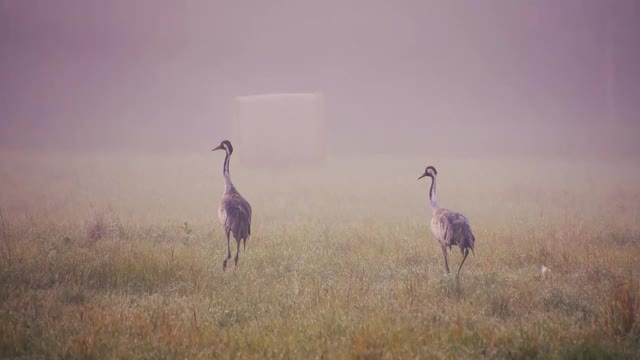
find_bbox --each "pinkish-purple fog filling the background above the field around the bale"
[0,0,640,159]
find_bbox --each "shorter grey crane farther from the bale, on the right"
[418,166,476,277]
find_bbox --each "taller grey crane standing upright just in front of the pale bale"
[211,140,251,271]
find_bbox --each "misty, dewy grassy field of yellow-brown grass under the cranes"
[0,152,640,359]
